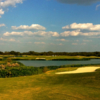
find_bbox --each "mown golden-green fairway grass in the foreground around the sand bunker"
[0,67,100,100]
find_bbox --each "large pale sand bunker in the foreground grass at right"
[55,67,100,74]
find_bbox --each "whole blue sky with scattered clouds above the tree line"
[0,0,100,52]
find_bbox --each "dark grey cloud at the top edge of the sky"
[56,0,100,5]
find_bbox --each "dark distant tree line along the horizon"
[0,51,100,56]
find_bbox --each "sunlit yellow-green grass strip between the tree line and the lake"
[0,55,100,60]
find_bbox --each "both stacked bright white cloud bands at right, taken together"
[60,23,100,37]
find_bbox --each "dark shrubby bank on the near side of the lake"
[0,62,100,78]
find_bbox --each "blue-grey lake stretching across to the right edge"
[18,59,100,67]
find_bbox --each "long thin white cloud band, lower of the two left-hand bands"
[3,31,59,37]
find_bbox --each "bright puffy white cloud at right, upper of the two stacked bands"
[62,23,100,31]
